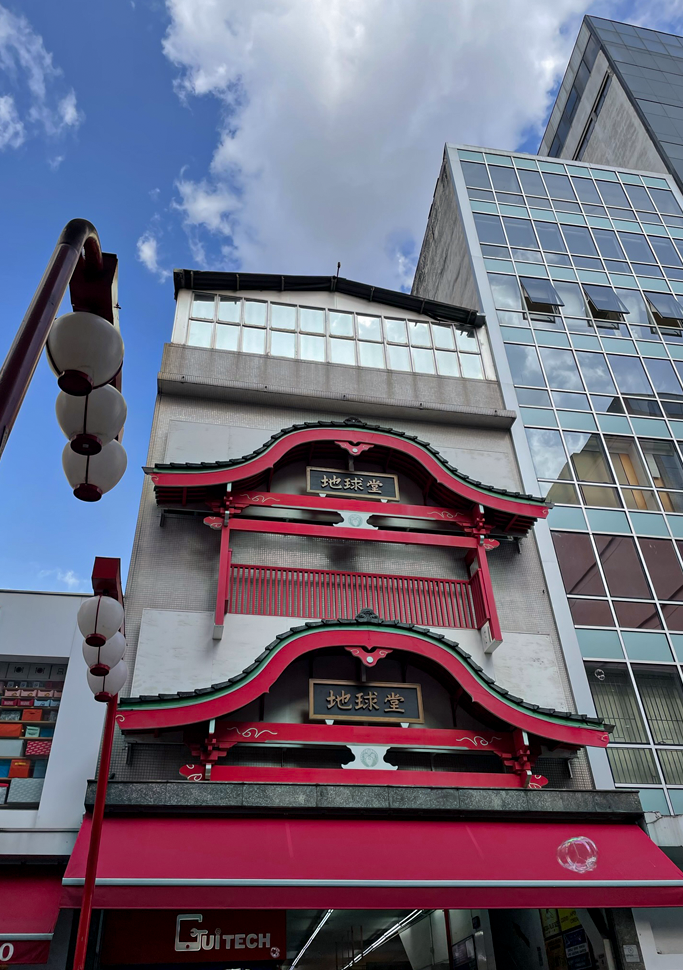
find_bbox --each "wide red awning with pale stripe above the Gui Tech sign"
[62,817,683,909]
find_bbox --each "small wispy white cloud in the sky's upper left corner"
[0,5,83,148]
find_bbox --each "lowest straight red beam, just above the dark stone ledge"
[211,765,548,789]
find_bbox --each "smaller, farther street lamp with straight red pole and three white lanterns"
[73,557,128,970]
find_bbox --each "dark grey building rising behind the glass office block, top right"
[539,16,683,188]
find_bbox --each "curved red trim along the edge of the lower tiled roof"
[118,625,609,747]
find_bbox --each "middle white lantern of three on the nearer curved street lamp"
[55,384,127,455]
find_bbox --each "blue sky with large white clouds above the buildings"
[0,0,683,592]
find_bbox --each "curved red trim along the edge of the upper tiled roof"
[147,428,550,519]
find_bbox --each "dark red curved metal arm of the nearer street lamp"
[0,219,103,457]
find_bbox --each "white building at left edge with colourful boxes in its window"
[0,590,103,968]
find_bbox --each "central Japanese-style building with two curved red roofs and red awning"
[49,270,683,970]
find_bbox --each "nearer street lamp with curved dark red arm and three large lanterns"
[0,219,126,502]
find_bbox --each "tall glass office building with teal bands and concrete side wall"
[414,146,683,816]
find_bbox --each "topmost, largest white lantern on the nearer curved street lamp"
[47,310,123,397]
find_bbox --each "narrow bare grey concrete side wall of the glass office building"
[412,158,482,310]
